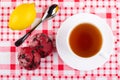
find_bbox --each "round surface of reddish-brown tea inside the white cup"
[69,23,102,58]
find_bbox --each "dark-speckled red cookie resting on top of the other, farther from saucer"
[18,47,41,70]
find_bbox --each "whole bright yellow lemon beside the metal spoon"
[8,3,36,30]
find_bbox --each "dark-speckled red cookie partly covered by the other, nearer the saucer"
[30,33,53,58]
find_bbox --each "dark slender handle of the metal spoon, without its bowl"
[15,20,42,47]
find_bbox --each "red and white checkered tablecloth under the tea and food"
[0,0,120,80]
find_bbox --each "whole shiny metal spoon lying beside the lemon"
[15,4,59,47]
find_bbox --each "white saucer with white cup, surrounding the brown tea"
[56,13,114,70]
